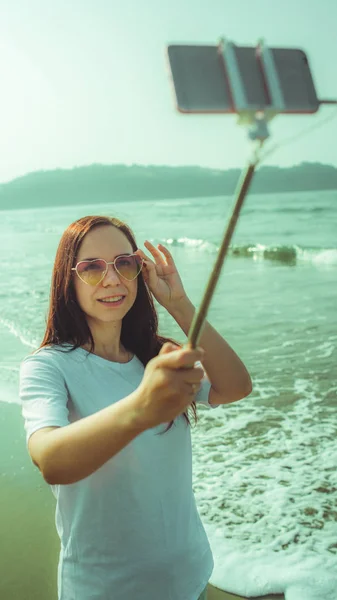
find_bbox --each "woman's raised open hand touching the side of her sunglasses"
[135,240,186,311]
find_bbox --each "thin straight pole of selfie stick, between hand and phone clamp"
[187,150,258,348]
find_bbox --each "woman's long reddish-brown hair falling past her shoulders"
[40,216,197,431]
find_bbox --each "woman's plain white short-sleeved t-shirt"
[20,346,218,600]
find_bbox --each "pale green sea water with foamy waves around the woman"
[0,191,337,600]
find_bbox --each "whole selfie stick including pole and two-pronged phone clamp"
[187,39,285,348]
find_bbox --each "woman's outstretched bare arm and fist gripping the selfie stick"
[26,344,203,485]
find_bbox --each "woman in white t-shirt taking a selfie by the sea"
[20,216,251,600]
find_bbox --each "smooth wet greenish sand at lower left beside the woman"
[0,403,59,600]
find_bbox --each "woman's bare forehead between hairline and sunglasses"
[78,225,133,258]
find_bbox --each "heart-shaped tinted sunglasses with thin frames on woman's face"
[71,254,143,285]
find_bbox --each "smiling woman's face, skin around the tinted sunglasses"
[74,225,137,325]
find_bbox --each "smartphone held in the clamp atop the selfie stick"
[167,44,320,114]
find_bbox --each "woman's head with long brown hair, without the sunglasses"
[42,216,160,364]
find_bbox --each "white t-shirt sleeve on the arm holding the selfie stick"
[19,353,69,444]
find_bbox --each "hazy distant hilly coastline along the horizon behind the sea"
[0,162,337,210]
